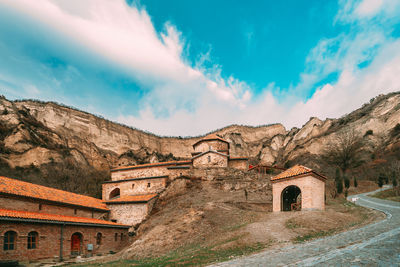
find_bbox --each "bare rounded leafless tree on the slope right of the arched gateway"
[322,130,364,174]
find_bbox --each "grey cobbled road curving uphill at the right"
[211,188,400,267]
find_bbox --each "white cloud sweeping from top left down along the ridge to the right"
[3,0,400,136]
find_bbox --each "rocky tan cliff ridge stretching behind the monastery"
[0,92,400,197]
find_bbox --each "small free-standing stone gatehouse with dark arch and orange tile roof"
[271,165,326,214]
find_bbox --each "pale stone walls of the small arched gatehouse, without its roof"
[272,175,325,214]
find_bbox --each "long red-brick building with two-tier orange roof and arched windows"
[0,176,129,263]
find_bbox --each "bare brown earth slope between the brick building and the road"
[85,180,383,264]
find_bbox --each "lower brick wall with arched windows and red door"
[0,221,130,262]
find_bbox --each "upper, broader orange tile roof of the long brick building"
[0,176,108,211]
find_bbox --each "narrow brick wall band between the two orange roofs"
[0,195,108,219]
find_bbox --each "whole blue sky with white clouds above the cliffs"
[0,0,400,136]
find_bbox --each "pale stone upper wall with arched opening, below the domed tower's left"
[103,177,168,200]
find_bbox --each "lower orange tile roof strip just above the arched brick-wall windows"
[0,209,129,227]
